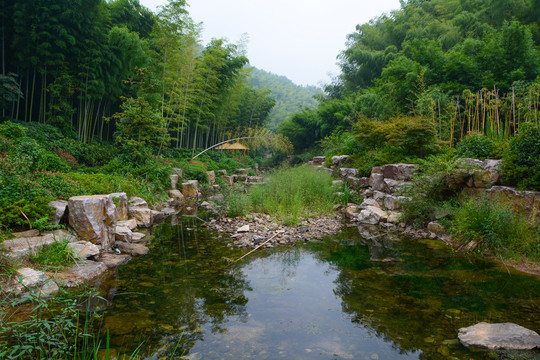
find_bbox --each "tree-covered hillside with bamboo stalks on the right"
[281,0,540,150]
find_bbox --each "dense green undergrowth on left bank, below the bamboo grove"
[0,121,272,237]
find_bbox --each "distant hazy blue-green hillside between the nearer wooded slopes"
[249,68,322,131]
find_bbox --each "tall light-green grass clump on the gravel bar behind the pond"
[248,165,336,224]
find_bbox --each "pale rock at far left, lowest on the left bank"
[6,268,59,297]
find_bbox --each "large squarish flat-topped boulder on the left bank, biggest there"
[68,195,116,250]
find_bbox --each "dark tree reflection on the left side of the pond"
[106,218,254,358]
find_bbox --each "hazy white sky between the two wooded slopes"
[139,0,400,85]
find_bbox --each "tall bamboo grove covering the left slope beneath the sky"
[0,0,274,149]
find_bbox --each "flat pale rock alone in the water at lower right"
[458,322,540,350]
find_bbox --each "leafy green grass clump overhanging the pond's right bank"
[451,199,540,259]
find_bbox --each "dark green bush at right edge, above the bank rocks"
[502,123,540,190]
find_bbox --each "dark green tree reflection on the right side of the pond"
[310,233,540,359]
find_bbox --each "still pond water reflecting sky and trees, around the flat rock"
[97,218,540,360]
